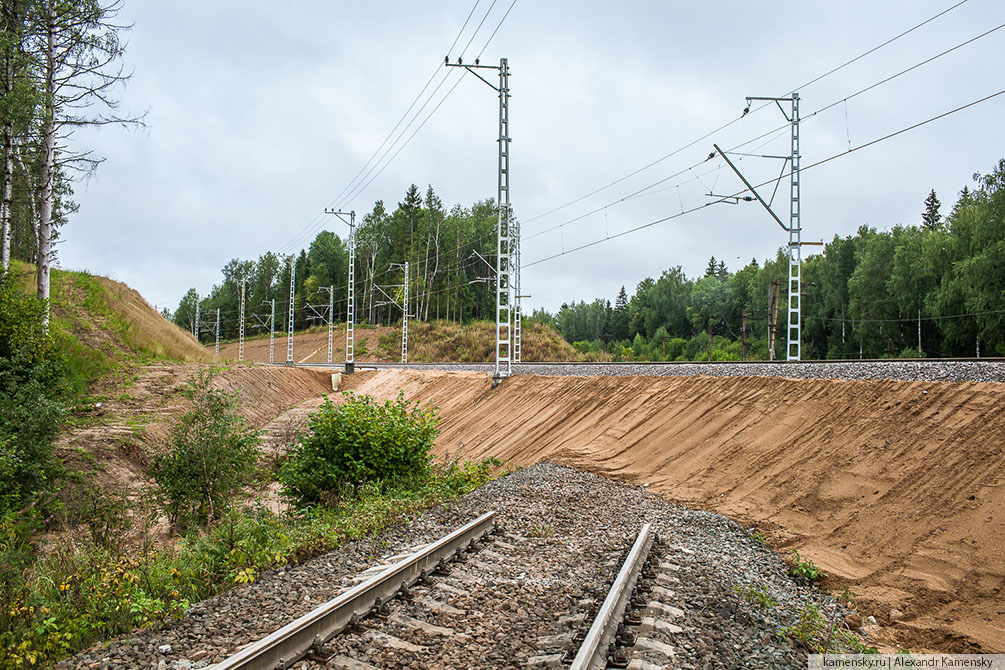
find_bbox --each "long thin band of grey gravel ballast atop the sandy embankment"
[357,361,1005,383]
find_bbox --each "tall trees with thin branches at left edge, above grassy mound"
[0,0,135,322]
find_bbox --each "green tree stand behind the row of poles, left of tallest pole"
[164,184,510,342]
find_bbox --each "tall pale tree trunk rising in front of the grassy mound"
[36,4,56,327]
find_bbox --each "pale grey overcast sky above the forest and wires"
[58,0,1005,310]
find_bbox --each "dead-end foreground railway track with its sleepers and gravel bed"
[60,464,843,670]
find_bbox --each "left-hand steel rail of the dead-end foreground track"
[209,511,495,670]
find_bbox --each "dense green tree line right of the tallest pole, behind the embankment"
[555,160,1005,361]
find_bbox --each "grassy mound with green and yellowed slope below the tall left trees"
[11,262,209,393]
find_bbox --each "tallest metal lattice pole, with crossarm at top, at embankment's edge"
[444,56,520,388]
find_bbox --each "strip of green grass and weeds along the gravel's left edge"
[0,461,497,668]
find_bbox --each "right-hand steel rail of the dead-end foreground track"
[569,523,652,670]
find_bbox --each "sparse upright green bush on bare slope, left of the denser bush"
[151,371,258,527]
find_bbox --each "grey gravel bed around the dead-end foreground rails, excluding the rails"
[59,464,856,670]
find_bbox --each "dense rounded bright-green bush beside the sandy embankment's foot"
[279,393,438,505]
